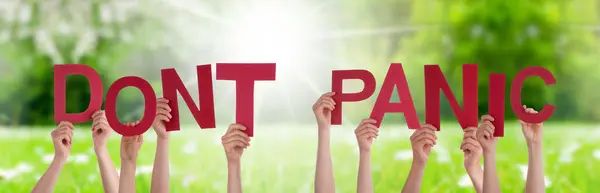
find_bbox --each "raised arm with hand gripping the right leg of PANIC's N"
[460,127,483,193]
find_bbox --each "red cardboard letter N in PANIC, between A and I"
[425,64,478,131]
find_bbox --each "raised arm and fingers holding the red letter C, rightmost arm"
[519,106,546,193]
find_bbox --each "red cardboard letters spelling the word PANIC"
[331,63,556,137]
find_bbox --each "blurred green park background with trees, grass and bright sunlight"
[0,0,600,192]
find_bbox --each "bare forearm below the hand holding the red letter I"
[483,152,501,193]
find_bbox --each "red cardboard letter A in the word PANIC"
[370,63,421,129]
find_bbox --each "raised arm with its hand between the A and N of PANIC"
[402,124,437,193]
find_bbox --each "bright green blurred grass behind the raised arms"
[0,123,600,193]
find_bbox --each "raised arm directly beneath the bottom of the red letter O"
[119,124,144,193]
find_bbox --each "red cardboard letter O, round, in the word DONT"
[105,76,156,136]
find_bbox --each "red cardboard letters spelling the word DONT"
[54,63,276,136]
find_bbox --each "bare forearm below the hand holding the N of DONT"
[150,137,169,193]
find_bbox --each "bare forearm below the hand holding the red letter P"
[315,127,335,193]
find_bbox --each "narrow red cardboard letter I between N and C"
[488,74,506,137]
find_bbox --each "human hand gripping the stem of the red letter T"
[221,124,250,163]
